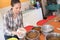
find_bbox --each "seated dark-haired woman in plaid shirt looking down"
[4,0,23,40]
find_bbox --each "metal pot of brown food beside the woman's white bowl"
[26,30,40,40]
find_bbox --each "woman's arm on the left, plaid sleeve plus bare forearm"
[3,15,17,35]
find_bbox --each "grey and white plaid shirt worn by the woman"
[4,10,23,35]
